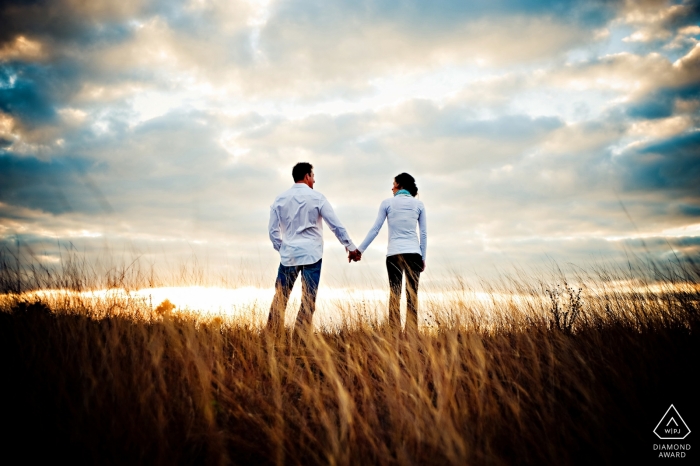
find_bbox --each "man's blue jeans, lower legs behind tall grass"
[267,259,323,333]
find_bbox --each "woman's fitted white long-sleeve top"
[357,194,428,260]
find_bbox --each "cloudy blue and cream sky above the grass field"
[0,0,700,287]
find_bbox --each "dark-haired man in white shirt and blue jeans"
[267,162,357,333]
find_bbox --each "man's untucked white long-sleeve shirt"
[268,183,356,266]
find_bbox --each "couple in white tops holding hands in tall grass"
[267,162,427,332]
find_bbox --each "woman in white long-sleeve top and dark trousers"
[350,173,428,333]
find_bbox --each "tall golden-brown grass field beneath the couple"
[0,253,700,465]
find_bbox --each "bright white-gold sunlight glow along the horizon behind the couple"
[9,280,700,327]
